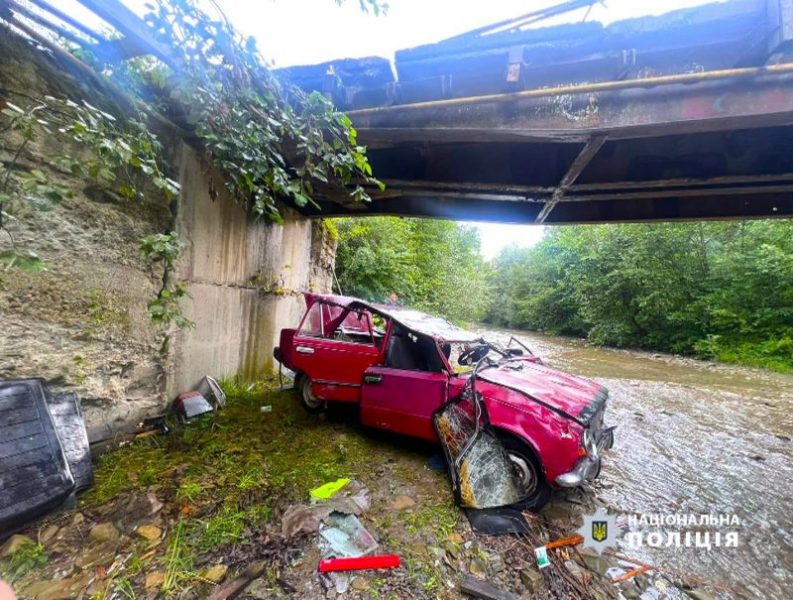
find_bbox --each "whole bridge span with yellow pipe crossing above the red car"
[281,0,793,224]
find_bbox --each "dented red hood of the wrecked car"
[476,359,608,426]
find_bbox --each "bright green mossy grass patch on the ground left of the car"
[76,379,430,596]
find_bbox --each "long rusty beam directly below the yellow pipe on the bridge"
[350,74,793,147]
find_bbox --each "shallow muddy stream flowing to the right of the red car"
[481,330,793,599]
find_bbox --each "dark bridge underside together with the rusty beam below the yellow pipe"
[306,75,793,225]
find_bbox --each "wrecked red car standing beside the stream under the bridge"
[274,293,613,510]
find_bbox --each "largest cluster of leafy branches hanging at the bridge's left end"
[137,0,382,222]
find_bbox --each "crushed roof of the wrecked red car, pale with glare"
[305,293,482,342]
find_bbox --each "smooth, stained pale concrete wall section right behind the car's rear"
[167,145,335,396]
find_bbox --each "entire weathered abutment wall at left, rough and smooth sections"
[0,36,335,439]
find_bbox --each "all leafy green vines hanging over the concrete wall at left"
[0,0,388,327]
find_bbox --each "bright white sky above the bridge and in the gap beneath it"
[43,0,724,259]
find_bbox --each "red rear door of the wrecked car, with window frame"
[293,302,380,402]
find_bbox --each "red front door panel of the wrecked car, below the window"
[361,366,449,441]
